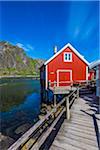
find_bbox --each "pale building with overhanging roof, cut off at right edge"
[89,60,100,97]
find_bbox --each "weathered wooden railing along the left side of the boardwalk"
[8,88,79,150]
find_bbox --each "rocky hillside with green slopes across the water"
[0,41,44,76]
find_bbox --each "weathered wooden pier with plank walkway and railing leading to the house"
[8,81,99,150]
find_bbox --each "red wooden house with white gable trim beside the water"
[40,43,89,99]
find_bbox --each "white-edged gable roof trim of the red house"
[44,43,89,65]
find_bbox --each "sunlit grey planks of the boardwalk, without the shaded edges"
[50,98,100,150]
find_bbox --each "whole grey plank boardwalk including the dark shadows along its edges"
[40,89,100,150]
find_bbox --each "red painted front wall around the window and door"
[47,48,87,86]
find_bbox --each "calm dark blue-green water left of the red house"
[0,78,41,139]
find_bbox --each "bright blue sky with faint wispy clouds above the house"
[0,1,100,62]
